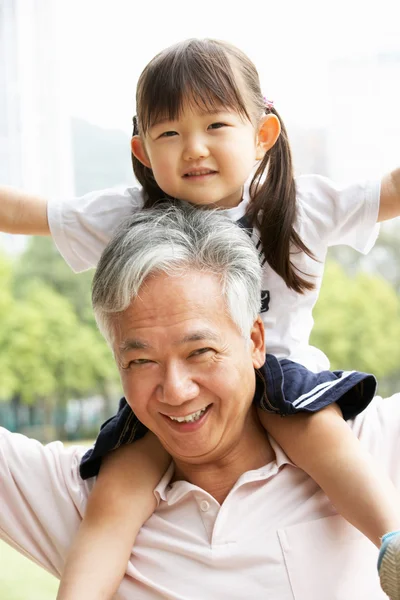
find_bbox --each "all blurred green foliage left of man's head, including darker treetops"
[0,238,118,407]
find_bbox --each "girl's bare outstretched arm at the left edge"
[0,186,50,235]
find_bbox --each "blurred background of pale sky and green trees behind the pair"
[0,0,400,600]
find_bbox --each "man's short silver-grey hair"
[92,202,261,345]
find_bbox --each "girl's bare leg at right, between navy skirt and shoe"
[258,405,400,548]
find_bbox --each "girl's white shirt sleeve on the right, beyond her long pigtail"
[296,175,380,254]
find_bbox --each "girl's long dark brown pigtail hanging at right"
[248,107,315,294]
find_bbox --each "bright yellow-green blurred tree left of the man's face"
[0,280,118,435]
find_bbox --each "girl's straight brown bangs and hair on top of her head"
[136,40,250,133]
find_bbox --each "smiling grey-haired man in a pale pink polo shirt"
[0,208,400,600]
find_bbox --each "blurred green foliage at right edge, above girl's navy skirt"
[311,262,400,379]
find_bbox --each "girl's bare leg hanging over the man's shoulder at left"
[57,433,171,600]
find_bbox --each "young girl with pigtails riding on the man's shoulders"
[0,40,400,600]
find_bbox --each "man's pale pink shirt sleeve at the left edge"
[0,428,91,577]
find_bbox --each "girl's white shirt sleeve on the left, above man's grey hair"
[47,188,143,273]
